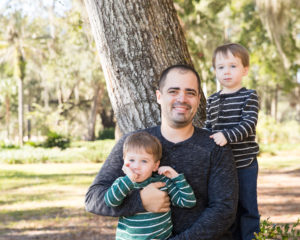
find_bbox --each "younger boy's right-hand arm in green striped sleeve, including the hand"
[158,166,196,208]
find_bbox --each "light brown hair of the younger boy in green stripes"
[123,131,162,161]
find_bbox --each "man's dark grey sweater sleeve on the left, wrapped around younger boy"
[85,135,145,217]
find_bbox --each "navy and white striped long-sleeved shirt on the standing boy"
[204,88,259,168]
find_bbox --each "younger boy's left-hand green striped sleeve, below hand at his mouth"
[104,176,134,207]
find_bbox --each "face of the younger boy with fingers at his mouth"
[124,149,160,182]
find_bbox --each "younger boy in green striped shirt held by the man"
[105,132,196,240]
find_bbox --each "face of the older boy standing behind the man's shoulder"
[215,51,248,93]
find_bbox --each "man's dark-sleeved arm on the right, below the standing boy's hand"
[169,146,238,240]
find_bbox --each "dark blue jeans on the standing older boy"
[232,158,260,240]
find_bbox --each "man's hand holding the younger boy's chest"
[140,182,170,213]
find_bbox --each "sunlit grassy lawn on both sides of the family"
[0,142,300,240]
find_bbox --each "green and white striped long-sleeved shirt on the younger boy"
[104,174,196,240]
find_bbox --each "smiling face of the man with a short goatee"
[156,69,200,128]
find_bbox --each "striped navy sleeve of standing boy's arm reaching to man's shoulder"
[222,91,258,143]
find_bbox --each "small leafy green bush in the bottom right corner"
[255,219,300,240]
